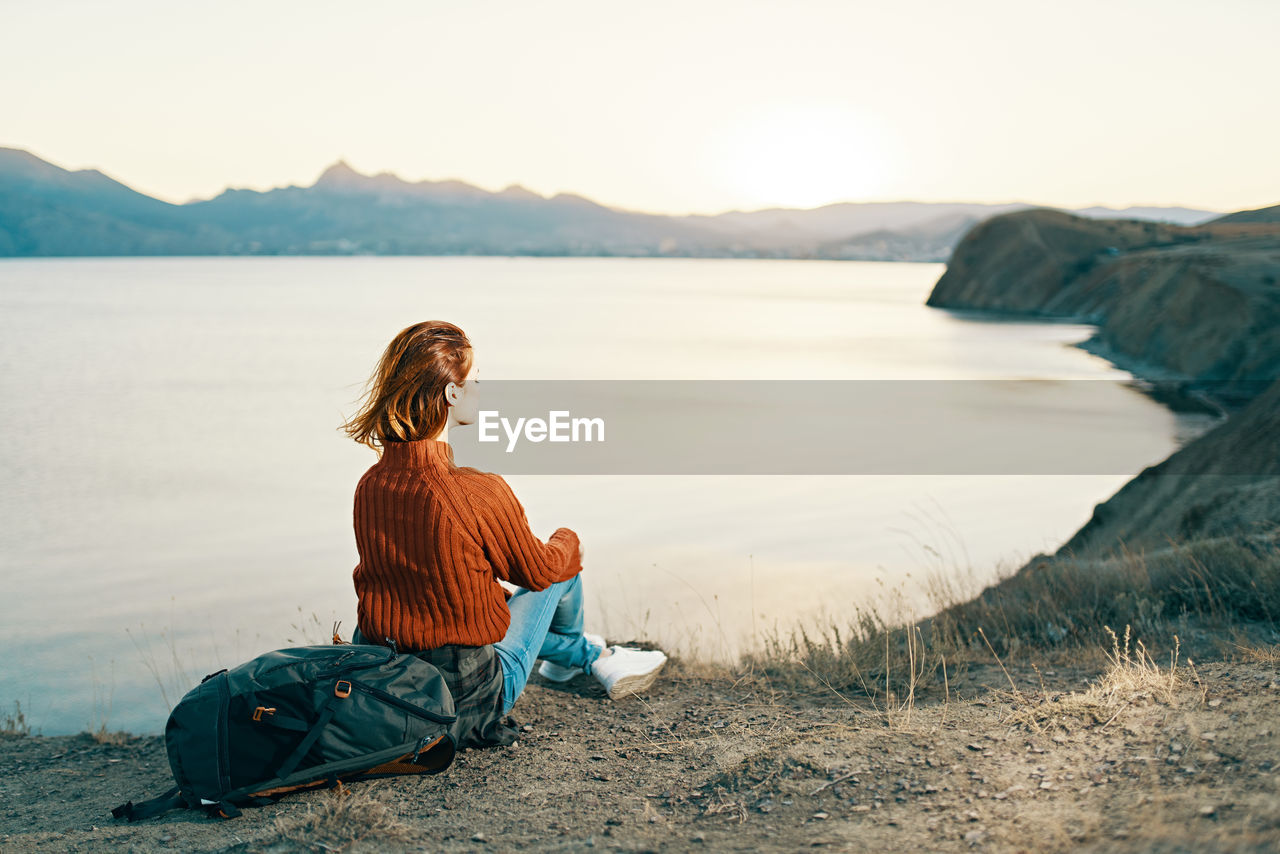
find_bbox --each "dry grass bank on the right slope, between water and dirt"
[741,536,1280,711]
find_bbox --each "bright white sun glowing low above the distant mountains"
[714,104,891,207]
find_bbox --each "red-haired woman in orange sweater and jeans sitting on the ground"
[342,320,667,748]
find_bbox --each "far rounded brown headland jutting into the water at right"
[927,209,1280,406]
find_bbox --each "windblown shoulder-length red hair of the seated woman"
[338,320,472,455]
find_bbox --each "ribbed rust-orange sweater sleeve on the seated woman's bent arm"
[467,472,582,590]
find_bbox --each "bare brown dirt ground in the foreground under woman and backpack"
[0,650,1280,853]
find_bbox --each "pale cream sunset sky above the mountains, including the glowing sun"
[0,0,1280,214]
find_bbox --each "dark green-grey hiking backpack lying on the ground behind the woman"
[111,644,457,822]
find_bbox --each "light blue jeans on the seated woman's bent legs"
[494,574,600,714]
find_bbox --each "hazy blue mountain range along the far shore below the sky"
[0,147,1221,261]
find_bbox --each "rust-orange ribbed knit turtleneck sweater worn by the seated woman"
[353,439,582,650]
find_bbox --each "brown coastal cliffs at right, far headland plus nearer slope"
[927,209,1280,557]
